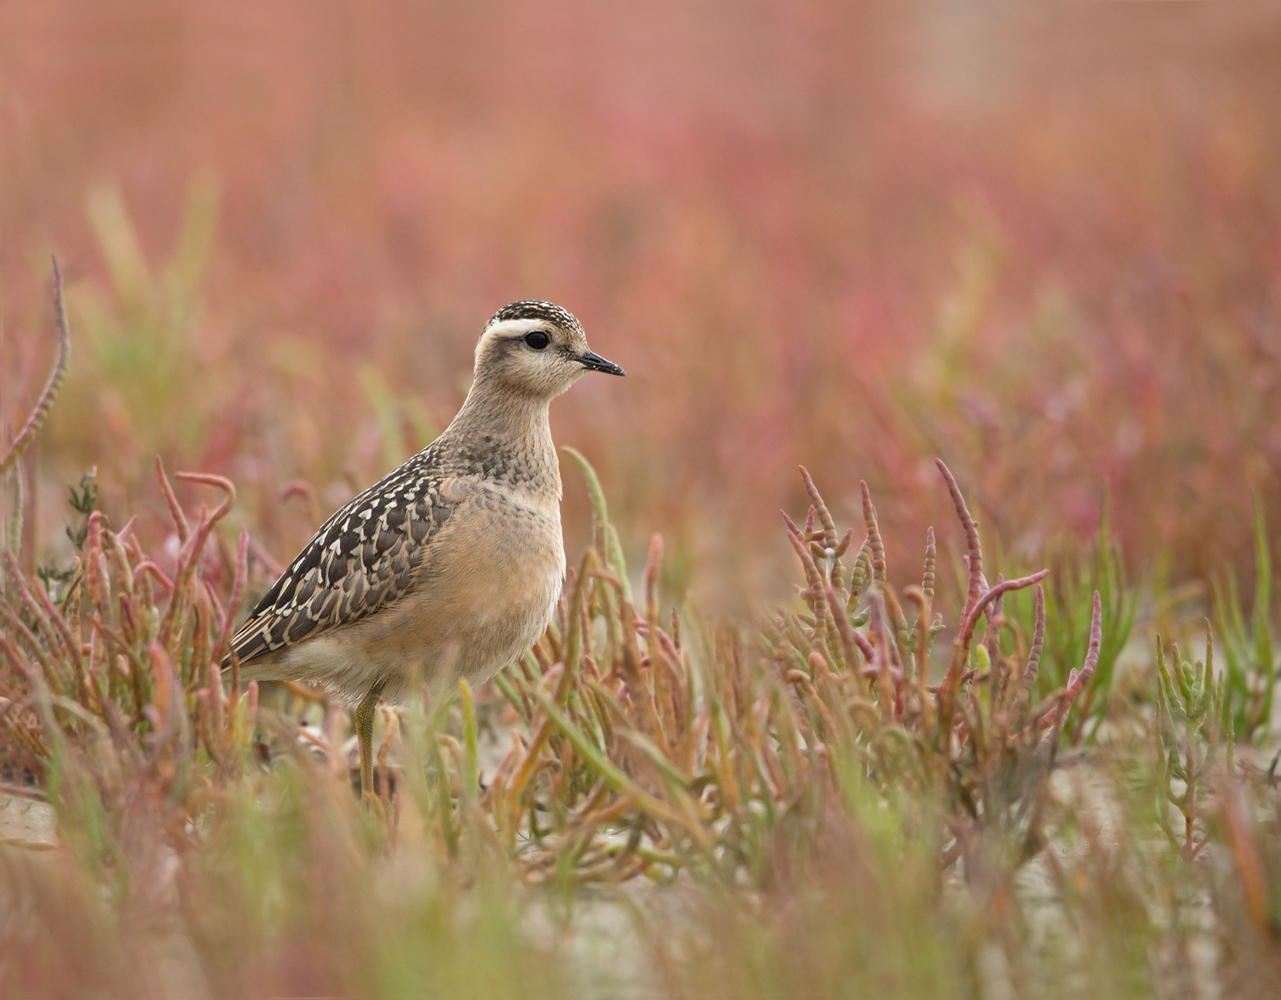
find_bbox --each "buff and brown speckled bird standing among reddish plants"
[224,300,625,796]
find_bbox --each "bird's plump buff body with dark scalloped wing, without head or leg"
[232,425,565,700]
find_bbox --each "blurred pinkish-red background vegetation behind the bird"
[0,0,1281,603]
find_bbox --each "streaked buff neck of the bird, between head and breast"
[441,379,560,501]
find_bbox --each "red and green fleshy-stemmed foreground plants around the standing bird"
[0,343,1281,997]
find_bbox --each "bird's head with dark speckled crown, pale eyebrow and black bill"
[475,300,624,399]
